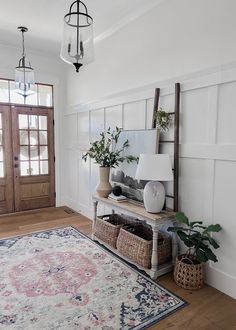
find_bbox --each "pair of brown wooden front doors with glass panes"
[0,106,55,213]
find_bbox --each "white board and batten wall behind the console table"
[62,63,236,298]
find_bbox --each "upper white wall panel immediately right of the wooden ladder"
[181,88,208,143]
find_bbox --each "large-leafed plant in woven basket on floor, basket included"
[167,212,222,290]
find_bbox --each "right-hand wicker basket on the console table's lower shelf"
[116,224,171,268]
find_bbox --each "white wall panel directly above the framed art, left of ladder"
[123,100,146,130]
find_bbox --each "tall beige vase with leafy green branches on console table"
[82,127,137,197]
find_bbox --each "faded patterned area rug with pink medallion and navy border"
[0,227,185,330]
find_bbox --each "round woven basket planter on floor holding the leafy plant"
[174,254,203,290]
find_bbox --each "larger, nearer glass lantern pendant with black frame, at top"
[61,0,94,72]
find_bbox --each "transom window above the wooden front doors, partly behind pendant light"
[0,79,53,107]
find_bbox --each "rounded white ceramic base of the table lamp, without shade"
[143,181,165,213]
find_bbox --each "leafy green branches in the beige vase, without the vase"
[82,127,138,167]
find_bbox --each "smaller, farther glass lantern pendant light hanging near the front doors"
[15,26,35,97]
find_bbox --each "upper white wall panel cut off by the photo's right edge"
[217,82,236,144]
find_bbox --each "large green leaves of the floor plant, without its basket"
[167,212,222,263]
